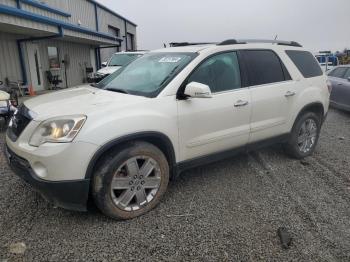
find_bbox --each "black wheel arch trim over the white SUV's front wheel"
[85,132,176,179]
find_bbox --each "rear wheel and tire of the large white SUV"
[284,112,322,159]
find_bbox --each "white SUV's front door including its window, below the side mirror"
[178,52,251,161]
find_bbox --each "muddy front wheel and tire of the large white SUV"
[92,142,169,220]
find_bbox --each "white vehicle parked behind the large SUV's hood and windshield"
[95,51,146,83]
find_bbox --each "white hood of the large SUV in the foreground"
[24,85,148,121]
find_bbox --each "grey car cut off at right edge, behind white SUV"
[328,65,350,111]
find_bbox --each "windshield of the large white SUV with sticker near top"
[97,53,197,97]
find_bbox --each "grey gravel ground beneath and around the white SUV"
[0,107,350,261]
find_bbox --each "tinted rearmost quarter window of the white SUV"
[286,50,323,78]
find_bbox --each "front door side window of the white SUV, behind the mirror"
[188,52,241,93]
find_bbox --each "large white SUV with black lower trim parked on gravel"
[6,40,330,219]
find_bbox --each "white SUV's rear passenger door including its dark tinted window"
[241,49,298,143]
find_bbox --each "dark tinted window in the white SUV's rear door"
[242,50,291,86]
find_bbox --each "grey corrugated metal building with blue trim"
[0,0,137,91]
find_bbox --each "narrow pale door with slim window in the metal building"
[27,43,44,91]
